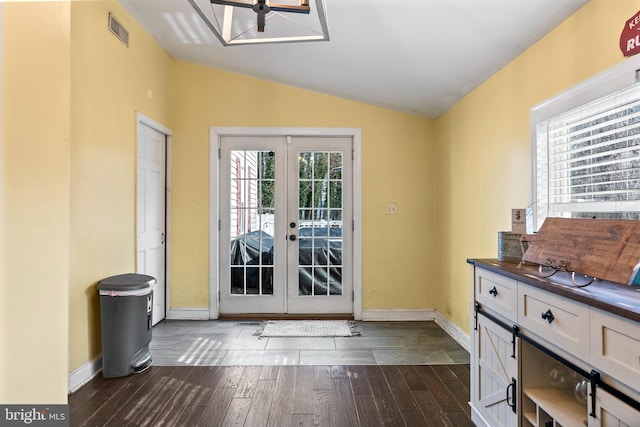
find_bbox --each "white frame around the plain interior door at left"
[133,112,173,319]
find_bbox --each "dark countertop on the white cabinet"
[467,259,640,322]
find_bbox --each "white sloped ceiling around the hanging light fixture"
[119,0,588,118]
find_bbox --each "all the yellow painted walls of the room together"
[0,0,640,403]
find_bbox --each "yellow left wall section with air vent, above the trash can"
[69,0,171,371]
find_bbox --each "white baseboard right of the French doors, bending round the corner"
[362,309,471,351]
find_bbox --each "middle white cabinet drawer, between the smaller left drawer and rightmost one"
[518,284,589,360]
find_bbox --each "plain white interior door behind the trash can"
[136,123,166,325]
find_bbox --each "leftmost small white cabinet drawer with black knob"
[475,268,518,322]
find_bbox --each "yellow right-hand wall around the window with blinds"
[435,0,640,331]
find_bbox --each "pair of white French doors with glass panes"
[219,136,353,314]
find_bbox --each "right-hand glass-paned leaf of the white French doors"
[287,137,353,313]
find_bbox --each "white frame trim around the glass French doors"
[209,127,362,320]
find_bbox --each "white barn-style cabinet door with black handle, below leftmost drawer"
[472,316,518,427]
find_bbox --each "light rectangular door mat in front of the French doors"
[254,320,361,338]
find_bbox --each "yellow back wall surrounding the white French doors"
[171,61,435,309]
